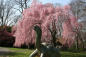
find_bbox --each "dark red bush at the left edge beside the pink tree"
[0,26,15,47]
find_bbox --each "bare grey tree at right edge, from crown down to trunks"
[70,0,86,48]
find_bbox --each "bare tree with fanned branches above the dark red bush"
[0,0,15,26]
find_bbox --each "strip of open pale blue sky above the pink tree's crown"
[39,0,71,5]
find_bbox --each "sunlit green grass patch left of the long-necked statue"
[5,48,34,57]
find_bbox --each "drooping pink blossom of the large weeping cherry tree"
[14,2,78,47]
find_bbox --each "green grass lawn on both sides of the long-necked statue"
[0,48,86,57]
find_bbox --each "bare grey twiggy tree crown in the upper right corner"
[70,0,86,19]
